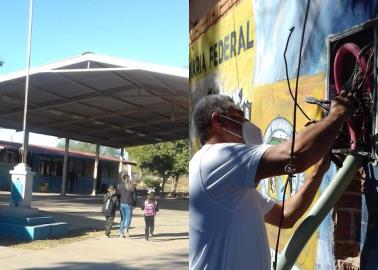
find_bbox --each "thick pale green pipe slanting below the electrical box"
[277,155,363,270]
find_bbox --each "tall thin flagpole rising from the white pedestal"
[21,0,33,164]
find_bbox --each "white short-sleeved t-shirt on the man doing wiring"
[189,143,275,270]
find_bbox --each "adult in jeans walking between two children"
[117,173,137,238]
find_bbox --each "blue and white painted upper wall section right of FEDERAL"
[253,0,378,84]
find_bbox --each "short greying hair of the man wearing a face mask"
[192,95,236,145]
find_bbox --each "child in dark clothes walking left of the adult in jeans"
[102,185,118,237]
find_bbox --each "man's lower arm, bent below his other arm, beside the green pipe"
[265,155,330,228]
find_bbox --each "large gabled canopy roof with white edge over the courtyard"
[0,53,189,148]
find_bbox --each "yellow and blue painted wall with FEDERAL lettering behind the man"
[189,0,378,269]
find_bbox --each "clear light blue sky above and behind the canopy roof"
[0,0,189,146]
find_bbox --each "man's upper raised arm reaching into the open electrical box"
[256,92,351,179]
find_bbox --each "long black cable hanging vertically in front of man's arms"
[273,0,310,270]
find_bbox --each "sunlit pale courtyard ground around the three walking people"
[0,191,189,270]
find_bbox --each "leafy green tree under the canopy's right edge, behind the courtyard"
[127,140,189,194]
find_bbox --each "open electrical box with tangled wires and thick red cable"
[327,19,378,159]
